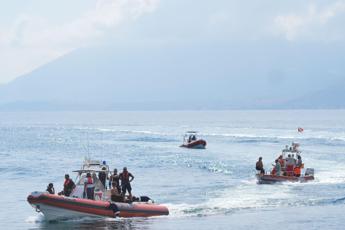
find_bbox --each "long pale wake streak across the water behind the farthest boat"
[77,128,345,146]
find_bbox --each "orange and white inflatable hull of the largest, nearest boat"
[27,193,169,220]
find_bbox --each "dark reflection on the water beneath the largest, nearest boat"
[34,218,151,230]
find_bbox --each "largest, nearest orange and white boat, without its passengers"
[27,160,169,221]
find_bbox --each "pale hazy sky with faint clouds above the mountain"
[0,0,345,83]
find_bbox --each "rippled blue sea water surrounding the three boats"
[0,110,345,229]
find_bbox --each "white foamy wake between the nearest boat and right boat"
[166,180,345,217]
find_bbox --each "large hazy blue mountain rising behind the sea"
[0,42,345,110]
